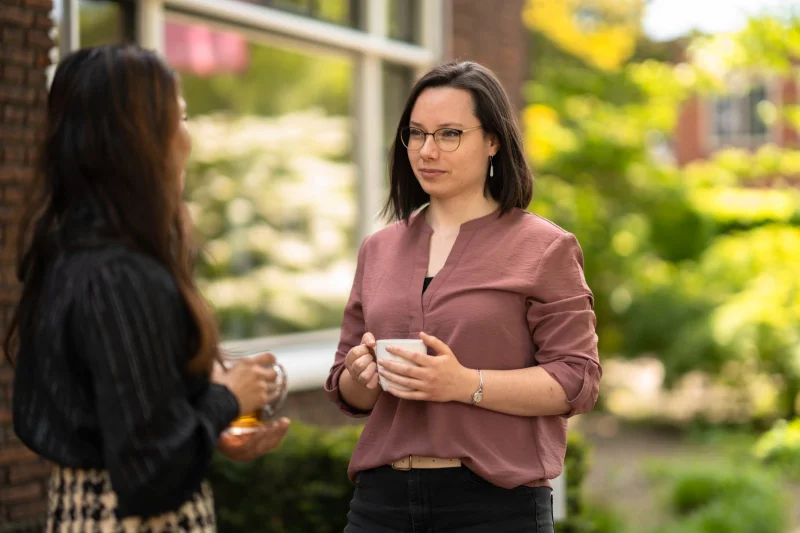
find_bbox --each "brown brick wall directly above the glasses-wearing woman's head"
[445,0,528,116]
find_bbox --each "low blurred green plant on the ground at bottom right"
[657,462,787,533]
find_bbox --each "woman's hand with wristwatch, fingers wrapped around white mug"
[378,333,480,403]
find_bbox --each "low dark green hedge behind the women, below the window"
[210,422,592,533]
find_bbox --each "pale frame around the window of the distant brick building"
[701,71,782,151]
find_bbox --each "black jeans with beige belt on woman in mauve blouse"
[344,466,554,533]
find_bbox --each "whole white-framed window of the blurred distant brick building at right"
[708,74,780,149]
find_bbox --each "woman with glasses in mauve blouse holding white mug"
[325,62,601,533]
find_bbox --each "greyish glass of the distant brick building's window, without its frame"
[711,83,770,147]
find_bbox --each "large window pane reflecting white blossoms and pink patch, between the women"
[166,21,357,339]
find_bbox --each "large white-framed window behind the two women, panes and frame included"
[57,0,444,390]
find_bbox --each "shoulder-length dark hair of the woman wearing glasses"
[382,61,533,221]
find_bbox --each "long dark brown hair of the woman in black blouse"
[3,45,219,373]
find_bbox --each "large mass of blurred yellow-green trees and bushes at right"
[524,7,800,416]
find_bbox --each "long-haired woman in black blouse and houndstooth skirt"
[5,46,288,533]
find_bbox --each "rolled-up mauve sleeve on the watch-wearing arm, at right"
[528,233,602,417]
